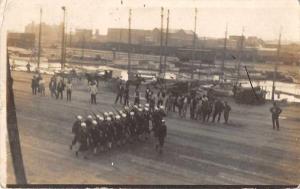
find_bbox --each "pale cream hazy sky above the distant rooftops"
[4,0,300,41]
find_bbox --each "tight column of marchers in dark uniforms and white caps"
[70,104,167,158]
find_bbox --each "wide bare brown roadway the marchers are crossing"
[7,72,300,184]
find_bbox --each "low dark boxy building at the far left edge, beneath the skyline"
[7,33,35,49]
